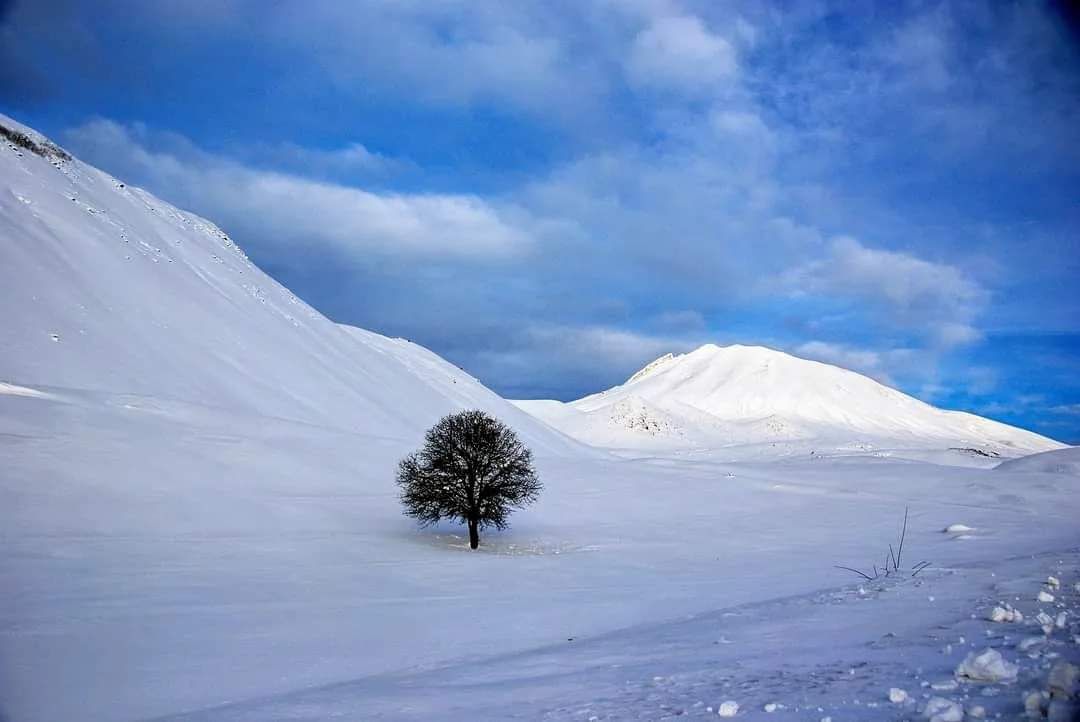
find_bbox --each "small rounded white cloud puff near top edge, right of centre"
[626,15,738,92]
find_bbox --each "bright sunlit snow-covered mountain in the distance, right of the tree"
[515,344,1063,457]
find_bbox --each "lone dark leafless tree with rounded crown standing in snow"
[397,411,541,549]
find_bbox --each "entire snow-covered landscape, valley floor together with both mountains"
[0,115,1080,722]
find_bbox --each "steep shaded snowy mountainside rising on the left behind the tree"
[0,115,578,451]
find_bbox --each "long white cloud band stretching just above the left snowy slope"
[67,120,531,259]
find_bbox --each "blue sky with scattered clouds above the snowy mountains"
[6,0,1080,441]
